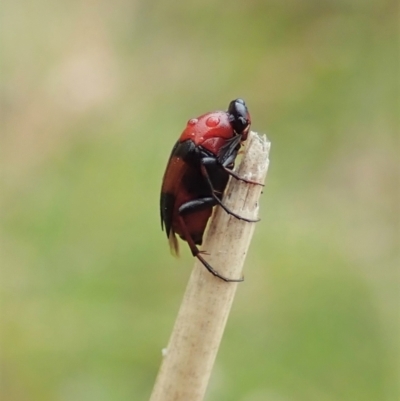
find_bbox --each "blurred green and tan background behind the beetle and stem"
[1,0,400,401]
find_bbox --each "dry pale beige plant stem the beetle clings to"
[150,132,270,401]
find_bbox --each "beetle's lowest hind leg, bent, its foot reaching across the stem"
[178,198,244,283]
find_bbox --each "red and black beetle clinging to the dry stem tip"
[160,99,258,281]
